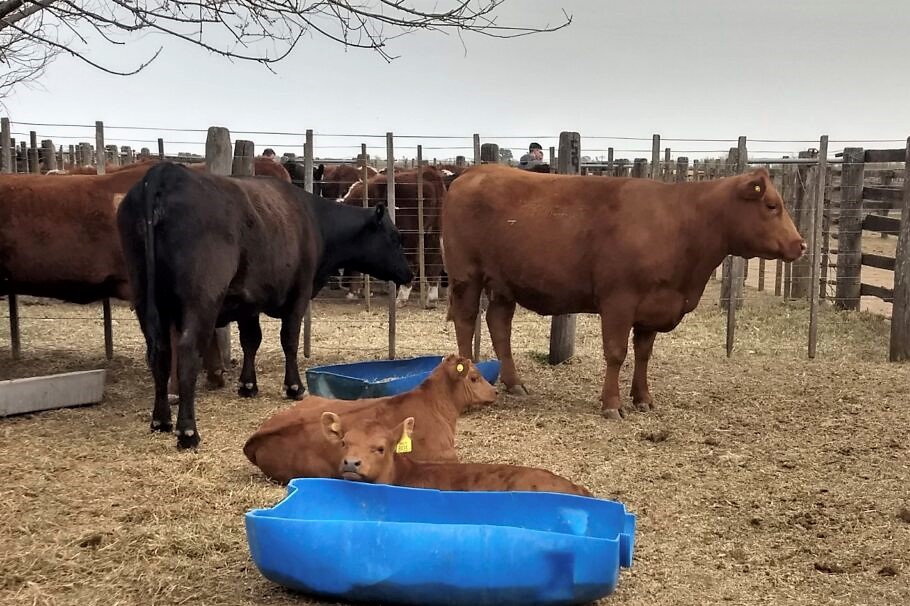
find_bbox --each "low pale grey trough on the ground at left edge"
[0,369,106,417]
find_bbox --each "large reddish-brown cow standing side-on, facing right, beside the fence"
[442,165,806,419]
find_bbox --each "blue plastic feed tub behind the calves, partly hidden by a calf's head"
[306,356,499,400]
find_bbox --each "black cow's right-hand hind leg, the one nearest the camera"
[176,311,208,448]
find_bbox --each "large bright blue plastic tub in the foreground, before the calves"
[246,478,635,606]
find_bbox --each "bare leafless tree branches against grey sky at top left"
[0,0,572,99]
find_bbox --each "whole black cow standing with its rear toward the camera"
[117,163,413,448]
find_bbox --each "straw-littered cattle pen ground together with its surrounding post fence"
[0,119,910,605]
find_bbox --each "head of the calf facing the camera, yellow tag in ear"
[321,411,414,484]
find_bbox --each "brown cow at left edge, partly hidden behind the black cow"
[0,160,290,395]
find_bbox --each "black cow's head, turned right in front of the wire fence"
[344,204,414,286]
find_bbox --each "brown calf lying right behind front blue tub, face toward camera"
[322,411,593,497]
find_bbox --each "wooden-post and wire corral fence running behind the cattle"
[0,118,910,363]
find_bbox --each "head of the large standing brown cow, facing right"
[727,168,806,262]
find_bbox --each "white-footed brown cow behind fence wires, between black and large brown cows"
[344,166,446,306]
